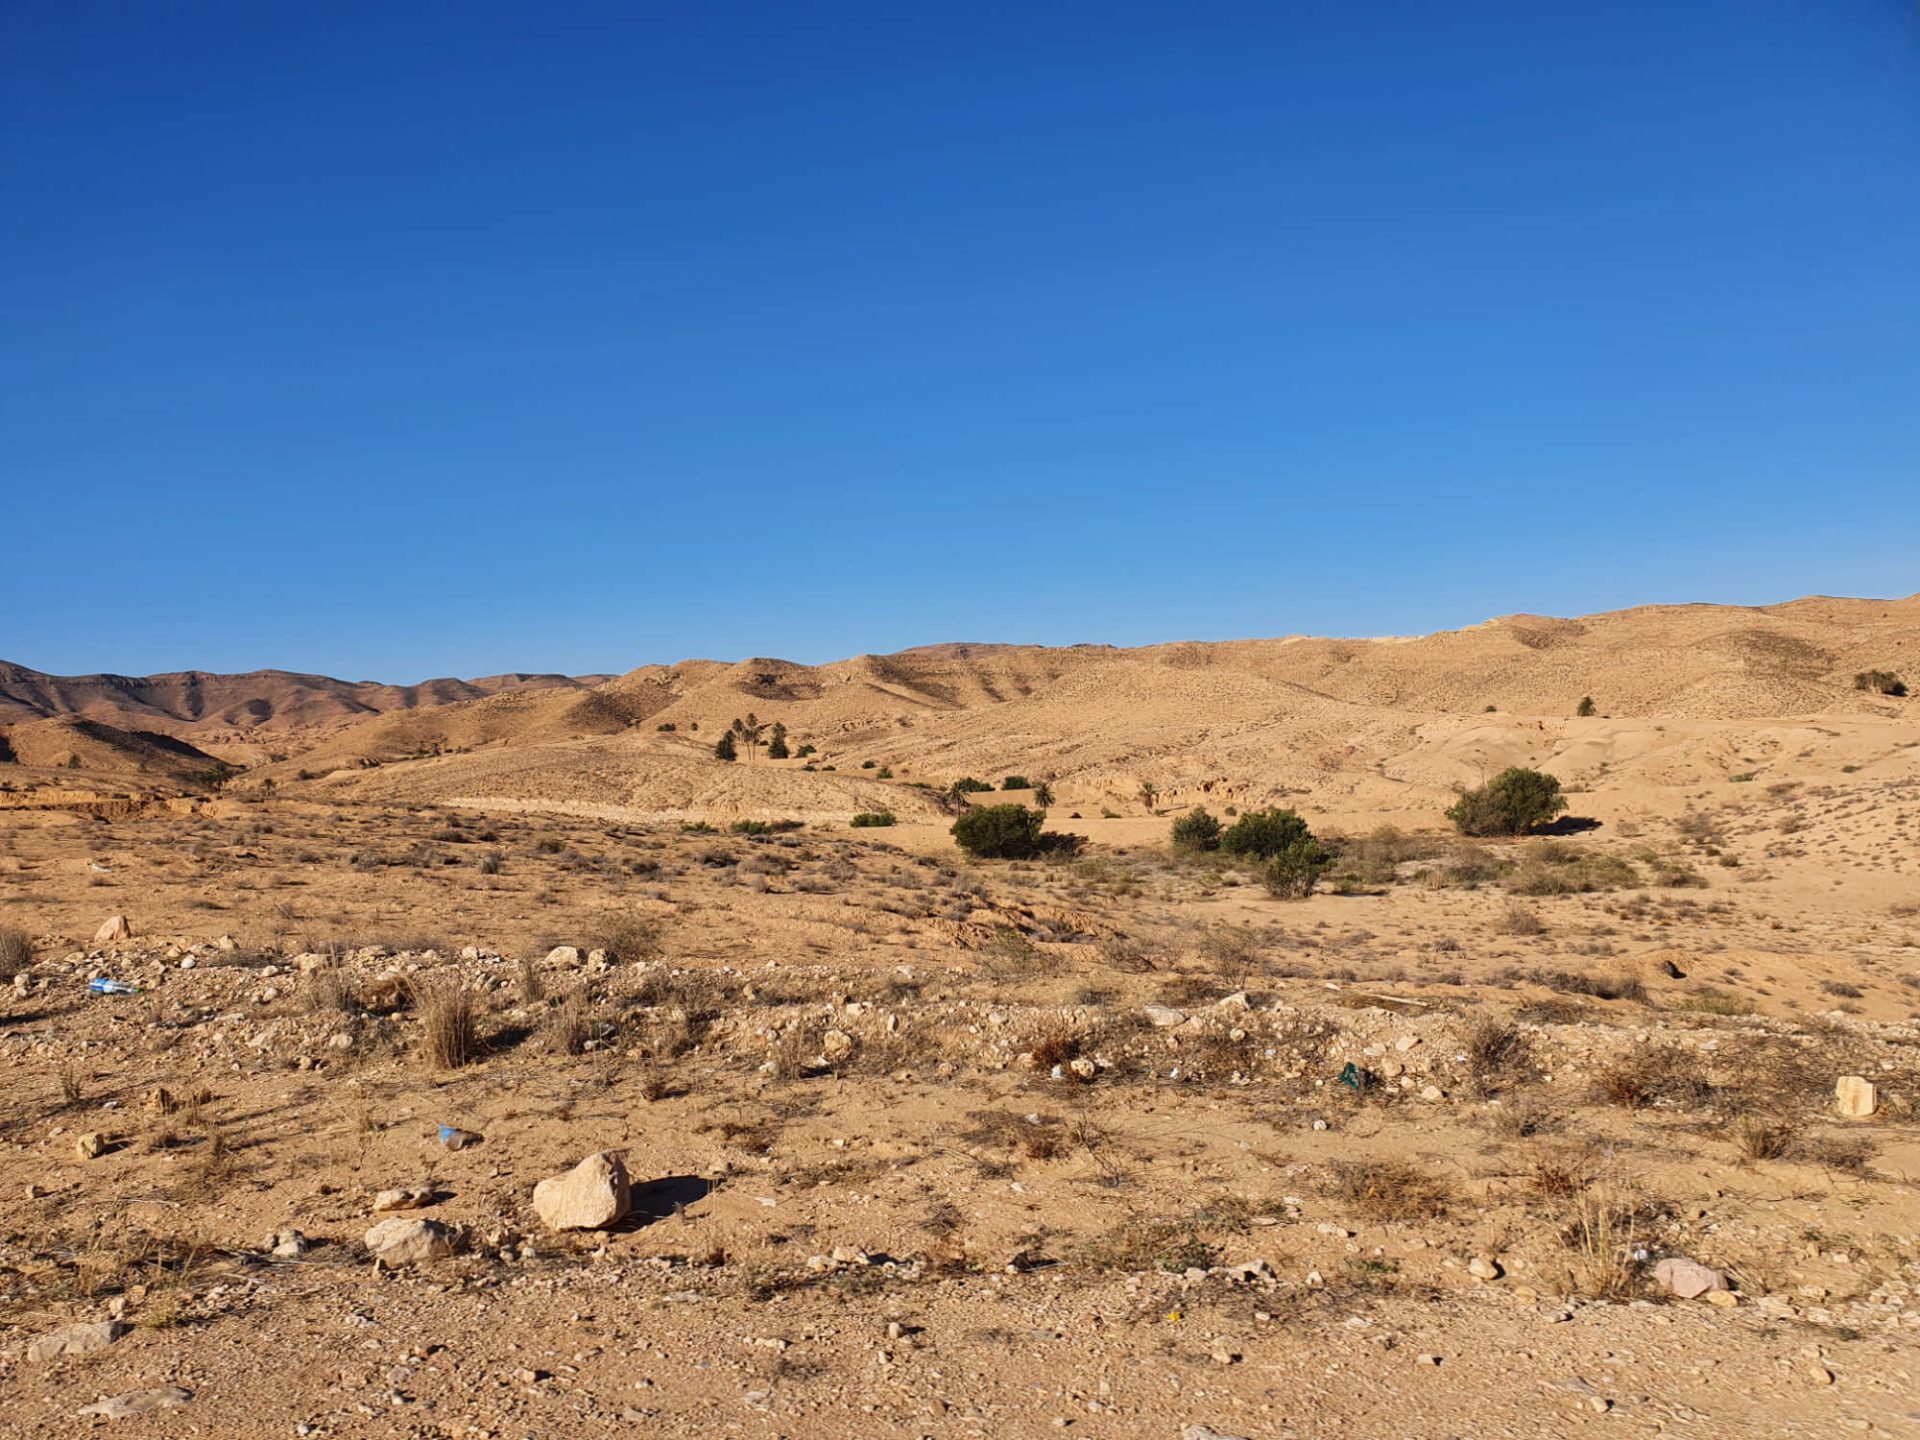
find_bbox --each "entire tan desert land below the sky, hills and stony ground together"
[0,595,1920,1440]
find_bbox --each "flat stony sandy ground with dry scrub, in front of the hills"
[0,770,1920,1438]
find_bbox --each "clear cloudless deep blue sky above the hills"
[0,0,1920,680]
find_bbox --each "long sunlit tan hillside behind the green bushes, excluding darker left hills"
[243,597,1920,818]
